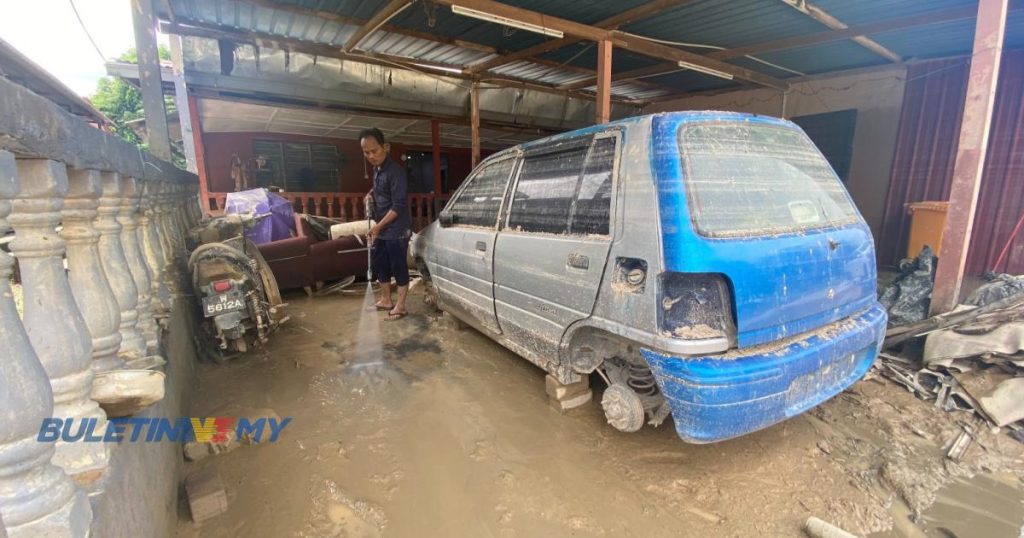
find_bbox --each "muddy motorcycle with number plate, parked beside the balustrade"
[188,215,287,363]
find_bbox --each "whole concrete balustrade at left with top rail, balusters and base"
[0,67,198,538]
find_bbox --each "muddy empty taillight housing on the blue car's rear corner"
[657,273,735,340]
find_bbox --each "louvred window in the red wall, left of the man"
[253,140,343,193]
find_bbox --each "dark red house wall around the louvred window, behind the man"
[203,132,486,193]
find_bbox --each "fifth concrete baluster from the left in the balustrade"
[118,177,160,355]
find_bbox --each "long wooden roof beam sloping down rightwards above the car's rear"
[437,0,786,89]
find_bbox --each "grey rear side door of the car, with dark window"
[495,131,620,359]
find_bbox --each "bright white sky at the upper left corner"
[0,0,167,96]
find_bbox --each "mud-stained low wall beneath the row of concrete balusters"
[89,299,196,538]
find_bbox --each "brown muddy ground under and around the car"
[177,286,1024,538]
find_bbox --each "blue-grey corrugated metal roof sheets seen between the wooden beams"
[158,0,1024,98]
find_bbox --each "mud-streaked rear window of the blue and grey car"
[679,122,858,237]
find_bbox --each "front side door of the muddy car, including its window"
[429,154,516,333]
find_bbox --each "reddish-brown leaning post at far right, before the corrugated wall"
[931,0,1009,315]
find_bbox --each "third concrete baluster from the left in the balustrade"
[60,170,124,372]
